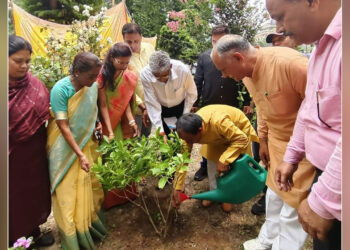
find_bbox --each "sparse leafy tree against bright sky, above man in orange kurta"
[211,0,265,42]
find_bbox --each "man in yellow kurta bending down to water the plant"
[174,104,258,212]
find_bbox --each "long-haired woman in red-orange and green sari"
[97,42,148,139]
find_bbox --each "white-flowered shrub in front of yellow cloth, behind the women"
[31,5,112,89]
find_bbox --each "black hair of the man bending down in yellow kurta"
[176,113,203,135]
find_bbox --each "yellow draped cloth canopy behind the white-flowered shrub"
[11,1,156,55]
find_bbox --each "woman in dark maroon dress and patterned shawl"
[8,35,54,246]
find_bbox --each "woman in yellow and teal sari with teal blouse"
[47,52,106,250]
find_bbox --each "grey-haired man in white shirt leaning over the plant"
[140,51,197,140]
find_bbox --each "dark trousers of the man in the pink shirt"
[310,168,341,250]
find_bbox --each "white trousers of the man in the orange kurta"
[258,188,307,250]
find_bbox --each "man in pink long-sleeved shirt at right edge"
[266,0,342,250]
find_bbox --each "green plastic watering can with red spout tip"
[180,154,267,204]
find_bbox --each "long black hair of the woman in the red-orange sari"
[102,42,132,91]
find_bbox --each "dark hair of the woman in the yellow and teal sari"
[69,52,102,75]
